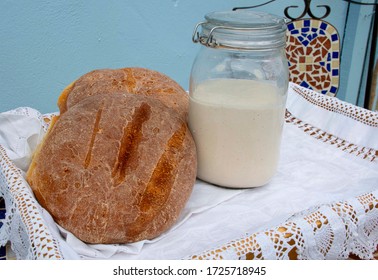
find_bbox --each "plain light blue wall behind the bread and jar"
[0,0,346,113]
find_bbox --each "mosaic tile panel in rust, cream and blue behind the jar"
[286,19,340,96]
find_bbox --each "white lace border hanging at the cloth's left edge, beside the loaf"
[0,145,63,259]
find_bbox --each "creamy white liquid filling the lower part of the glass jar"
[189,79,286,188]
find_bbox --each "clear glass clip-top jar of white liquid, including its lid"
[189,10,289,188]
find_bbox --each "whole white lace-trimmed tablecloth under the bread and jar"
[0,84,378,259]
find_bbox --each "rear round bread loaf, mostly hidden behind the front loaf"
[58,67,189,119]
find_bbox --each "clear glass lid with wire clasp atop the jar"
[192,10,287,50]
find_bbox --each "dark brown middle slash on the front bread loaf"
[112,103,151,185]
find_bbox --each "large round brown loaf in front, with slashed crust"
[27,94,197,243]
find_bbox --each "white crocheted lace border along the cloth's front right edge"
[186,190,378,260]
